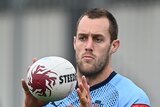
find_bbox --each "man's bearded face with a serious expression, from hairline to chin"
[74,16,111,77]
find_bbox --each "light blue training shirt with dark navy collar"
[45,72,150,107]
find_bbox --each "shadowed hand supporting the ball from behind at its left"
[21,58,47,107]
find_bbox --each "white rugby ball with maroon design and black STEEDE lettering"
[27,56,76,102]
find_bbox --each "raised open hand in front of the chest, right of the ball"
[77,76,92,107]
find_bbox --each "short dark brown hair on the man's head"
[77,8,118,42]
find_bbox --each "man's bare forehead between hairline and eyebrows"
[77,16,109,33]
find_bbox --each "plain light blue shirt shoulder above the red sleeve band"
[110,73,150,105]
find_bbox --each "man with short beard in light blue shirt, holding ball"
[22,8,150,107]
